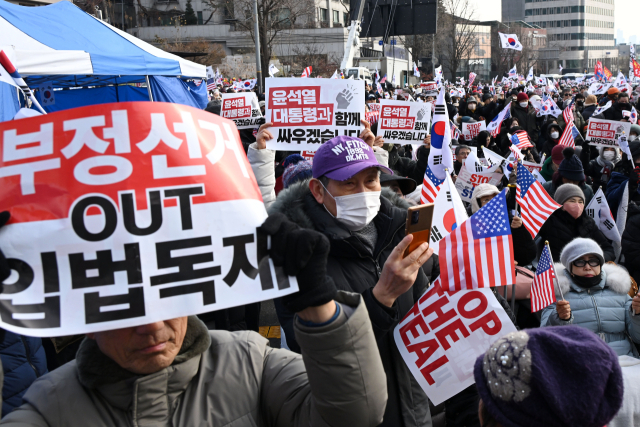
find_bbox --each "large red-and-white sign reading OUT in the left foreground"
[0,102,297,337]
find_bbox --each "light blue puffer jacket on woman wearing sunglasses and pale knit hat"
[540,263,640,357]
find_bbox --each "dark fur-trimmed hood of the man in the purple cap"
[269,179,410,229]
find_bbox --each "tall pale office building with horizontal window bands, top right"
[524,0,618,73]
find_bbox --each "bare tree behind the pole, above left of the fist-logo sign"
[229,0,315,83]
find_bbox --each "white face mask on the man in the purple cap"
[323,185,381,231]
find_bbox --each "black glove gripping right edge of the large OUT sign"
[260,213,337,313]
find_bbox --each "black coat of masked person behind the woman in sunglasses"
[538,208,615,261]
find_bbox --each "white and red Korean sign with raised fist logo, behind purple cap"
[266,78,364,151]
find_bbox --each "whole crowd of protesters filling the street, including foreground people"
[0,74,640,427]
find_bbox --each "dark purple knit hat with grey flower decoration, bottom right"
[473,325,624,427]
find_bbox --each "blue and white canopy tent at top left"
[0,0,207,117]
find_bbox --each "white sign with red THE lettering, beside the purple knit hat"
[393,279,516,405]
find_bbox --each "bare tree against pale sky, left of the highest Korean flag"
[436,0,477,79]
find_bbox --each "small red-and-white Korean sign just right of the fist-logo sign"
[376,100,431,145]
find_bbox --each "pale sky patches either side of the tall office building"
[469,0,640,44]
